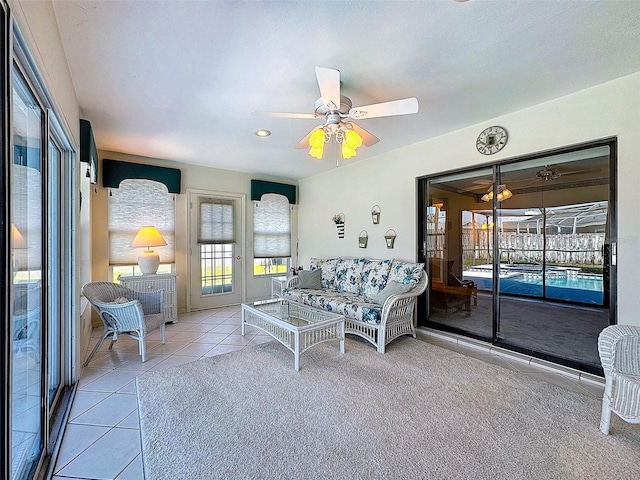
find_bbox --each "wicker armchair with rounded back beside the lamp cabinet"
[82,282,165,367]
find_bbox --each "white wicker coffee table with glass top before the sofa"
[242,299,344,371]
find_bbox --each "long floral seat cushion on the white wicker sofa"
[282,288,382,325]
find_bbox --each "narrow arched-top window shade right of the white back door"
[253,193,291,258]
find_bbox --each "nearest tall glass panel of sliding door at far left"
[10,69,43,479]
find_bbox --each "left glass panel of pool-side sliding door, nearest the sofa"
[425,169,493,339]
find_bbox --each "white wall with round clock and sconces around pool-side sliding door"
[298,73,640,325]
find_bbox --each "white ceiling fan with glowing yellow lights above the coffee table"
[254,67,418,159]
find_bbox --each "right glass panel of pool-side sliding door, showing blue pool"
[496,147,609,369]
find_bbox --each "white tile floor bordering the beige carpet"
[53,306,604,480]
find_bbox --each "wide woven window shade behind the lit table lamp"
[109,179,175,265]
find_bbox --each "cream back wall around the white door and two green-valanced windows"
[91,150,297,312]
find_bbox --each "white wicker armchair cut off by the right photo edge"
[598,325,640,434]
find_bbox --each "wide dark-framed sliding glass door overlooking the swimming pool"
[419,141,615,373]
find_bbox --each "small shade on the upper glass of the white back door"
[198,197,236,245]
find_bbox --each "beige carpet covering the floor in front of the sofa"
[137,337,640,480]
